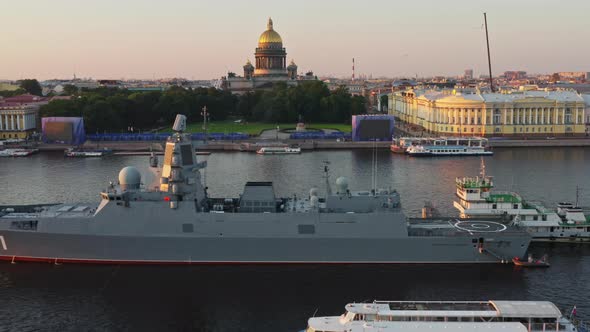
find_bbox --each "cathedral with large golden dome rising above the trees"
[222,18,308,94]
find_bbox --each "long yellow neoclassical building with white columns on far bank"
[388,90,586,137]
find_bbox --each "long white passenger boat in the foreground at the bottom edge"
[306,300,583,332]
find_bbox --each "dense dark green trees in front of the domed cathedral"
[35,81,366,132]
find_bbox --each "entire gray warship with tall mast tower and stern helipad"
[0,115,530,264]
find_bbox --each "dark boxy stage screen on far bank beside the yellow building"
[352,115,395,142]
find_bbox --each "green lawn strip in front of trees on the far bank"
[176,121,352,135]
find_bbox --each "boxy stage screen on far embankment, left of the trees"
[41,117,86,145]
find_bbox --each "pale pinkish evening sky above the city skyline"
[0,0,590,79]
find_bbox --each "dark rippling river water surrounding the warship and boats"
[0,148,590,331]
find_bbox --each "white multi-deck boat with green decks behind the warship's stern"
[453,163,590,242]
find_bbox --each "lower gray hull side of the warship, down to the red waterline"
[0,232,528,264]
